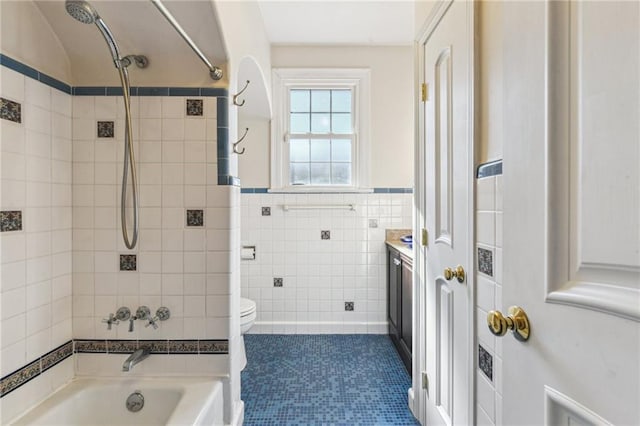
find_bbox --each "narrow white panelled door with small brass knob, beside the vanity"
[421,1,473,425]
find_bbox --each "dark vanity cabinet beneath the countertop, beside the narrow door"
[387,245,413,374]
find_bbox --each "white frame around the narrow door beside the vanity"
[409,0,479,424]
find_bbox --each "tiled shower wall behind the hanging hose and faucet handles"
[73,96,231,339]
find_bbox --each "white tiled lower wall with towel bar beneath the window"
[241,188,413,334]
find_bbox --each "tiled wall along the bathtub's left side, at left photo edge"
[0,67,73,423]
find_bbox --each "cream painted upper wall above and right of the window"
[240,46,413,188]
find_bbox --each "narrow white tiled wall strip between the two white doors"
[476,161,504,425]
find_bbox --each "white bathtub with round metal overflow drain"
[10,377,223,426]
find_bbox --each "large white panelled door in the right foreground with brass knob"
[498,1,640,425]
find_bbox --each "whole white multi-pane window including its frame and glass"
[271,69,369,191]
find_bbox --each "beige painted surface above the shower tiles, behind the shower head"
[35,0,226,86]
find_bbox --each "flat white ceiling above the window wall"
[258,0,414,45]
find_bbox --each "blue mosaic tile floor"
[242,334,418,426]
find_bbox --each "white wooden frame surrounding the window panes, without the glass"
[269,68,371,192]
